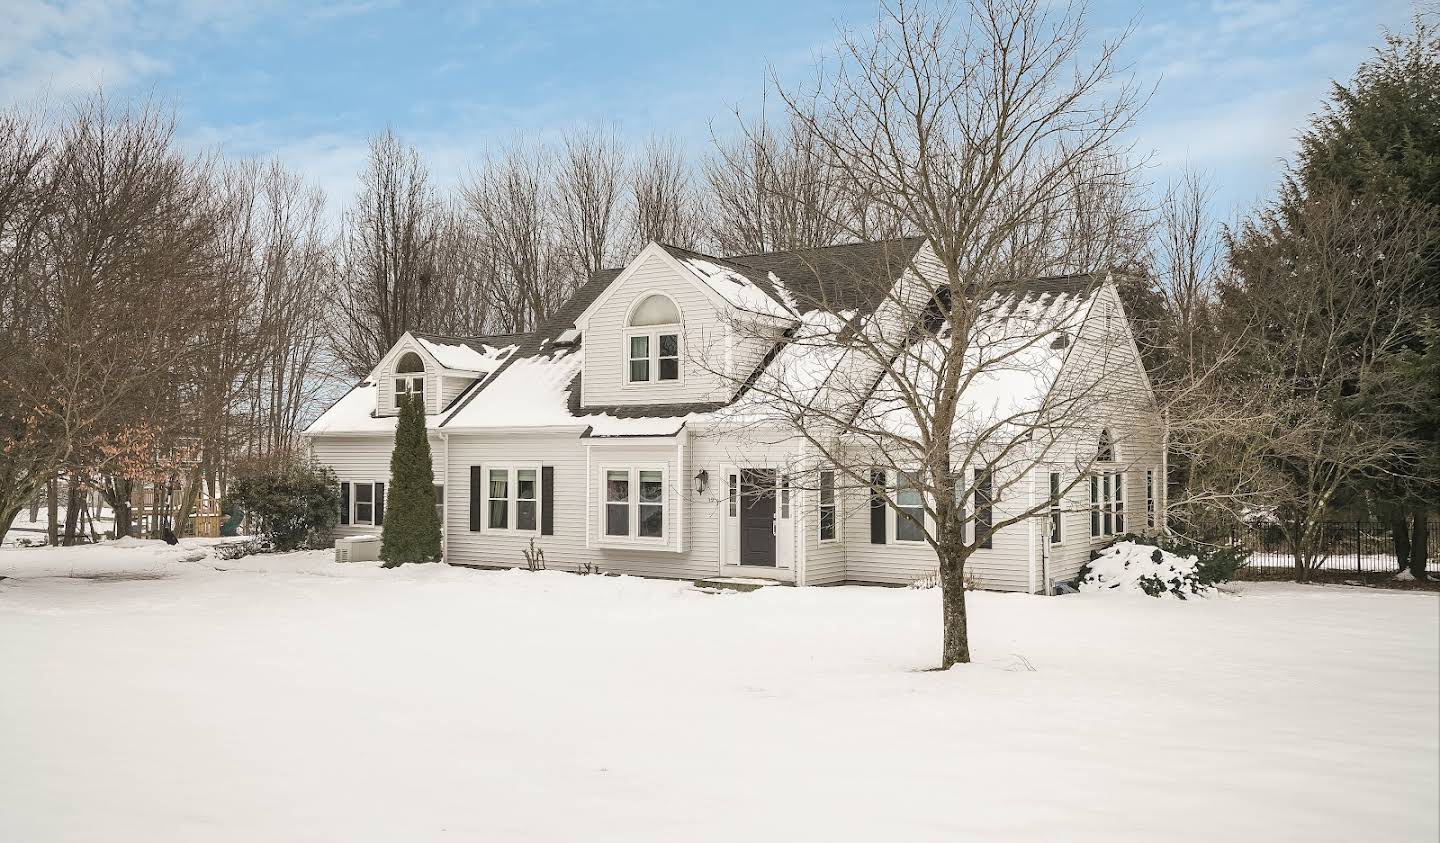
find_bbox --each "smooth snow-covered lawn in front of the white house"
[0,542,1440,843]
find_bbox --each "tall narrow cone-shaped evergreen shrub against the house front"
[380,398,441,568]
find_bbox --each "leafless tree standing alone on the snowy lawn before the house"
[705,0,1146,667]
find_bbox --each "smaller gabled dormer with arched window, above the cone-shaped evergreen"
[370,331,518,416]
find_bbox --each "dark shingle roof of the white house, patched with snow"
[307,239,1096,437]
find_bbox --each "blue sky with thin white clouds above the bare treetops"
[0,0,1410,219]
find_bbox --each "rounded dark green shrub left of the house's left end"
[226,463,340,550]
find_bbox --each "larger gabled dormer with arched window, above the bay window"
[575,242,795,408]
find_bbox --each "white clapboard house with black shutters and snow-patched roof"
[305,238,1165,592]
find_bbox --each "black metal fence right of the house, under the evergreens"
[1230,520,1440,574]
